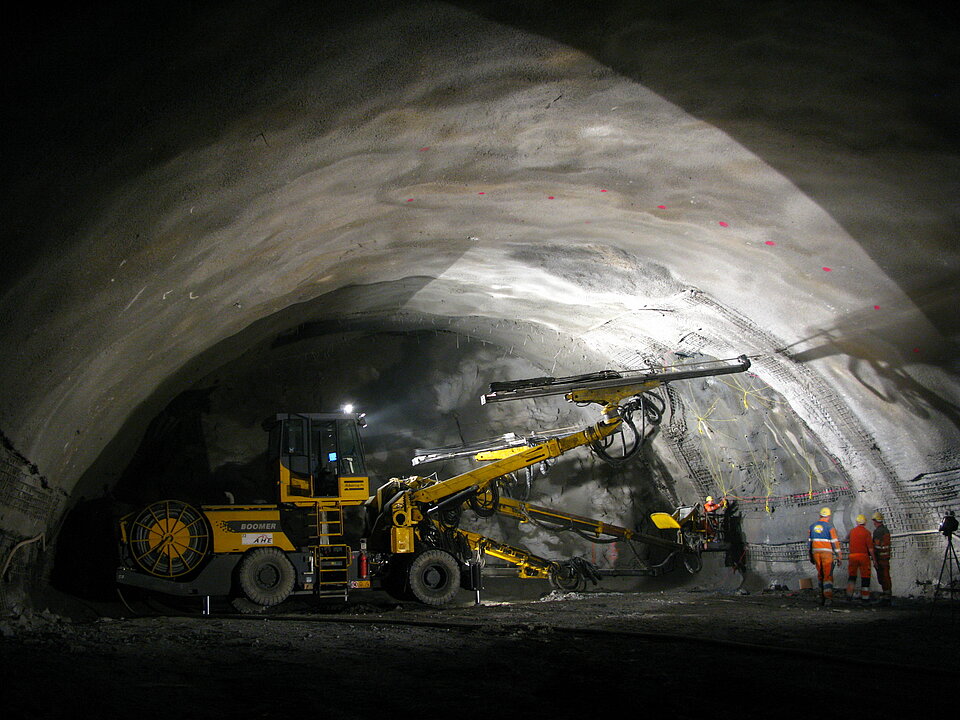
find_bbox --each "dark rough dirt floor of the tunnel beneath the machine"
[0,590,960,718]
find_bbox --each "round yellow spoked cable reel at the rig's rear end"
[129,500,210,578]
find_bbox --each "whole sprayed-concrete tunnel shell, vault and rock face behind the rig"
[0,3,960,604]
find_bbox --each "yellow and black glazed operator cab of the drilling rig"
[264,413,370,502]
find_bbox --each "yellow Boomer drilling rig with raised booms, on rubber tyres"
[116,356,750,612]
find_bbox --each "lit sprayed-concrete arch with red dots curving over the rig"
[0,4,960,608]
